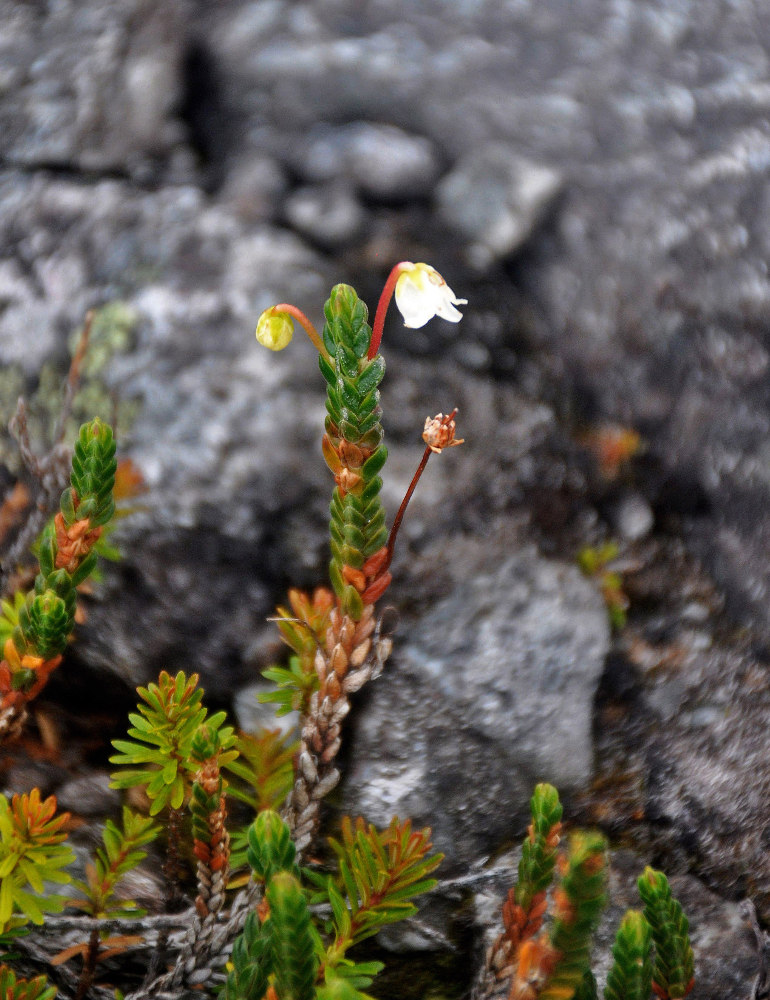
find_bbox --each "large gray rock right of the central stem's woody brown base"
[344,543,609,866]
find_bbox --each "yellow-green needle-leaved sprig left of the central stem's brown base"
[110,670,238,816]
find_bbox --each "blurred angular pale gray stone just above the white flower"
[436,143,564,269]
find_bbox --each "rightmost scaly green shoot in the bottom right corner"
[637,868,695,1000]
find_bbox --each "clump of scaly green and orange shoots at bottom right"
[487,784,693,1000]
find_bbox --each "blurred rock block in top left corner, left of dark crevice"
[0,0,187,173]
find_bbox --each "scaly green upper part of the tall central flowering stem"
[318,285,388,621]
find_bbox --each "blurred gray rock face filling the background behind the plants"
[0,0,770,998]
